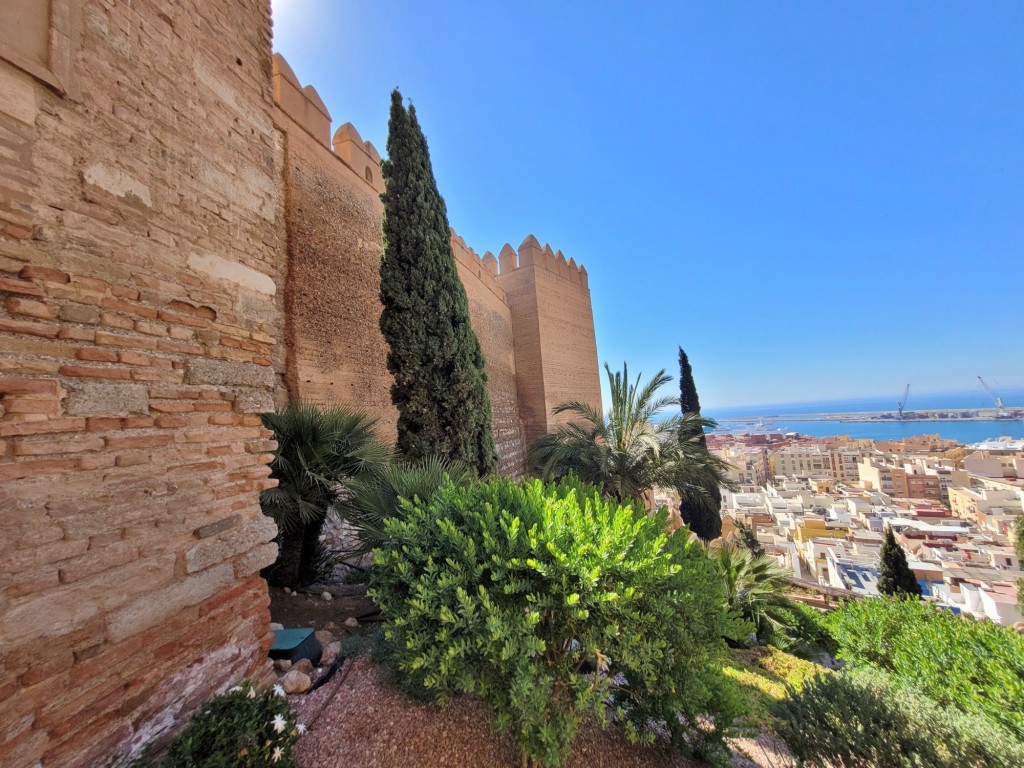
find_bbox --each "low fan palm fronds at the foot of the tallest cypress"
[334,456,476,556]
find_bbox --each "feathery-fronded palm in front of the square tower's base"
[528,362,728,503]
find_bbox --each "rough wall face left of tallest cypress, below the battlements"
[276,94,398,441]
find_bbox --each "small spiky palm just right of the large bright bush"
[709,541,795,646]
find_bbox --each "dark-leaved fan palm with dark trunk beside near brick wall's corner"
[260,400,392,586]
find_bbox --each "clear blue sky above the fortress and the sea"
[273,0,1024,409]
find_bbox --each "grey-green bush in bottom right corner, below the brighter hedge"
[769,668,1024,768]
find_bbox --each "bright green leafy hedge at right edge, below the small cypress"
[828,599,1024,737]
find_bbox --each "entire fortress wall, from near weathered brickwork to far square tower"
[0,0,600,768]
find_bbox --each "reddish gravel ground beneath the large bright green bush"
[291,657,785,768]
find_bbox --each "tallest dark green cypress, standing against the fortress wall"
[380,89,497,475]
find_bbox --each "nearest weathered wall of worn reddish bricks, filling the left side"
[0,0,286,768]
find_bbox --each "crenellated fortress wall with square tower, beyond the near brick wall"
[273,54,601,475]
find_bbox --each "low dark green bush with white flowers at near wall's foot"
[159,681,303,768]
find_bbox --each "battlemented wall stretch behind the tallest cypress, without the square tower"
[274,55,548,476]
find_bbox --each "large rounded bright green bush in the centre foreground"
[370,479,738,765]
